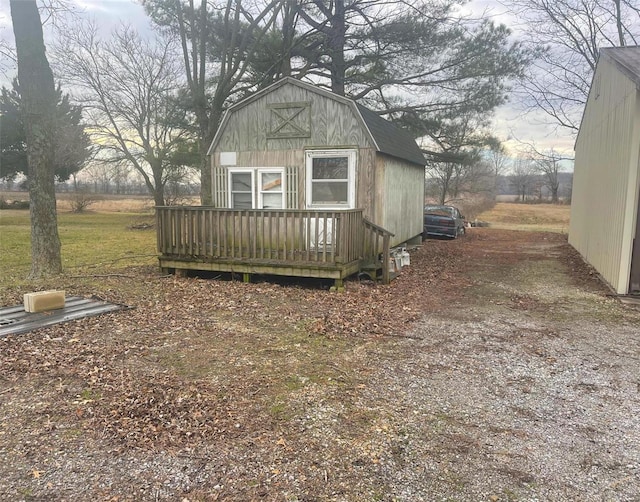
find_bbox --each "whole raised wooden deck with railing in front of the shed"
[156,206,392,286]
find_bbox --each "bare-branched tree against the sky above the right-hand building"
[502,0,640,134]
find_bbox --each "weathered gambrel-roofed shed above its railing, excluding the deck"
[209,77,425,245]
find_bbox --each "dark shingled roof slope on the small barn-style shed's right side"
[356,103,426,166]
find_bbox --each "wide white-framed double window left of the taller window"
[229,168,285,209]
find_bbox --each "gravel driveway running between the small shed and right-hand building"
[366,233,640,501]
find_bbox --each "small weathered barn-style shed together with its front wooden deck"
[158,78,425,283]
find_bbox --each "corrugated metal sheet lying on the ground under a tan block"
[0,296,131,337]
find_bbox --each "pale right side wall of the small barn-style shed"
[376,156,424,246]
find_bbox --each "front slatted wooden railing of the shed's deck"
[156,206,365,263]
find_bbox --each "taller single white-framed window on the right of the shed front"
[307,150,356,209]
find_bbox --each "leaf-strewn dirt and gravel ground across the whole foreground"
[0,228,640,502]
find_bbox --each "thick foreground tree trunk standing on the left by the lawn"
[10,0,62,278]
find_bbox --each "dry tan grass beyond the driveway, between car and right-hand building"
[478,202,571,233]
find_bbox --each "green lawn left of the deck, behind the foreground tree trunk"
[0,210,157,286]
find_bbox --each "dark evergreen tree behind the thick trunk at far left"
[0,80,91,181]
